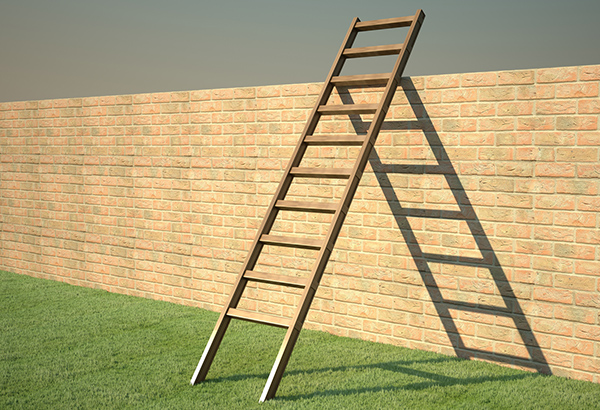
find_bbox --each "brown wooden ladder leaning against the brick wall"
[191,10,425,402]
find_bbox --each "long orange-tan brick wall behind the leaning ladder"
[0,65,600,382]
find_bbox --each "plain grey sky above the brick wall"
[0,0,600,102]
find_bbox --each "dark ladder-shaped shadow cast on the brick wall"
[338,78,551,374]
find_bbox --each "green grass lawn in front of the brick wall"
[0,272,600,409]
